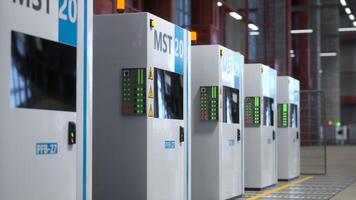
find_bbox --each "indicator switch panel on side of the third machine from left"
[200,86,219,121]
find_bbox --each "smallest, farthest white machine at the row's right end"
[277,76,300,180]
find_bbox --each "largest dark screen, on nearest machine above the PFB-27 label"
[10,31,77,112]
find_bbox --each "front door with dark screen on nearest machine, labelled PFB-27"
[0,31,77,200]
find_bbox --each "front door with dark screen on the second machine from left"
[147,68,187,200]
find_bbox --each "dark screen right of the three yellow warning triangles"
[154,68,184,119]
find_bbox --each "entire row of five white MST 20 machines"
[0,6,300,200]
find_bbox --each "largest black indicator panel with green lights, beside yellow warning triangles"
[122,68,146,116]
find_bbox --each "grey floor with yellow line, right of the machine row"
[239,146,356,200]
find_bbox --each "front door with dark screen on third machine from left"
[219,86,242,199]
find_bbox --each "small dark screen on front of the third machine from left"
[223,86,240,124]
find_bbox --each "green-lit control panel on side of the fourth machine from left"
[245,97,261,127]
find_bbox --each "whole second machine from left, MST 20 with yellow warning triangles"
[93,13,191,200]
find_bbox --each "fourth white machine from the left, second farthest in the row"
[243,64,277,189]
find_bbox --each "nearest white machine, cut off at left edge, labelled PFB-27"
[0,0,92,200]
